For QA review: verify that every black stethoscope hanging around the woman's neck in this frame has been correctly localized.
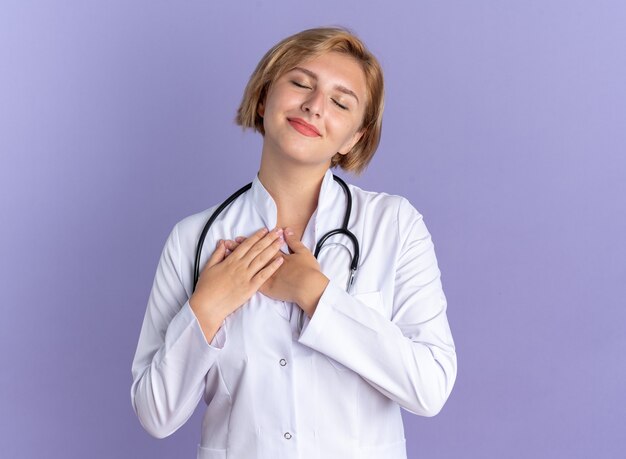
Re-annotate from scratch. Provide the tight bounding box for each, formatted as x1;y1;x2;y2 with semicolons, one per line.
192;174;359;330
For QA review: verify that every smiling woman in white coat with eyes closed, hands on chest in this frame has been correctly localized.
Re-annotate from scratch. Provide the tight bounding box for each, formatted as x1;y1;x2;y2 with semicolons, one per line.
131;28;456;459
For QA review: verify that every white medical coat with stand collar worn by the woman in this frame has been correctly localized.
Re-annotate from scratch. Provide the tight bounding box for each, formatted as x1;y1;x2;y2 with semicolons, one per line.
131;170;456;459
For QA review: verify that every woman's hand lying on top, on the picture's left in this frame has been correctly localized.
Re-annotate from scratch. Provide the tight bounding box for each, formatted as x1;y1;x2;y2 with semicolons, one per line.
189;228;284;342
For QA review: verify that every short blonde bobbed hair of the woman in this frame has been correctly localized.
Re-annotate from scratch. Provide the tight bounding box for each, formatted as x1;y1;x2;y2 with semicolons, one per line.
235;27;384;174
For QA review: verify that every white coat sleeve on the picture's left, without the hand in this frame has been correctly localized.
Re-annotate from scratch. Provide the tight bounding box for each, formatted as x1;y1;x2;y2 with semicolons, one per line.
131;227;223;438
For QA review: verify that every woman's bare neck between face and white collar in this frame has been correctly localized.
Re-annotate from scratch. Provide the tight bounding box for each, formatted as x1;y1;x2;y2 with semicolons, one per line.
259;151;328;232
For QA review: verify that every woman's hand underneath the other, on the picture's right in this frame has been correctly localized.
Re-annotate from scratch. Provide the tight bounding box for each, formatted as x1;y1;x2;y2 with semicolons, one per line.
227;228;329;317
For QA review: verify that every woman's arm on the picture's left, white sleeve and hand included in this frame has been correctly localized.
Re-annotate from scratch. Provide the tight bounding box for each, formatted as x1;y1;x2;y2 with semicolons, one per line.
131;225;282;438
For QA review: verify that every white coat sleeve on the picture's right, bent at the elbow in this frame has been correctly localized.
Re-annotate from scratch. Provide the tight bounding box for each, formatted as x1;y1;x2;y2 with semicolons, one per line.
300;199;456;416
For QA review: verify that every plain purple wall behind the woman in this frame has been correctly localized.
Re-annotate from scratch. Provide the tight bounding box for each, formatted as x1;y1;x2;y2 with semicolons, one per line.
0;0;626;458
